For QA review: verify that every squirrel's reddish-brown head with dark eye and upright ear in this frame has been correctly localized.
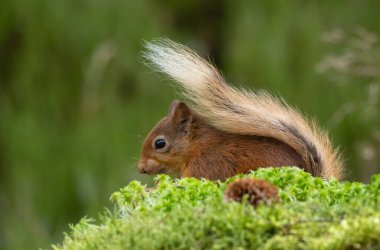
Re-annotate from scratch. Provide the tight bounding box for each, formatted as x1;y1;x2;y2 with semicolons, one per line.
138;101;194;174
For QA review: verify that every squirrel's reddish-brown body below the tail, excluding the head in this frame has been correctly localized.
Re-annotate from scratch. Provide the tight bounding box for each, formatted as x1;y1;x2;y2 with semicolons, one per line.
181;117;304;180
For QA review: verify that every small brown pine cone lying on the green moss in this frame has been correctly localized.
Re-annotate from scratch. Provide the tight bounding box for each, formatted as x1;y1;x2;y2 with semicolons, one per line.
224;178;280;207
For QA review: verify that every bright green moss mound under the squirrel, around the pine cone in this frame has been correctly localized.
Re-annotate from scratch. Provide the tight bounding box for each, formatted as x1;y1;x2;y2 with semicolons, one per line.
54;168;380;249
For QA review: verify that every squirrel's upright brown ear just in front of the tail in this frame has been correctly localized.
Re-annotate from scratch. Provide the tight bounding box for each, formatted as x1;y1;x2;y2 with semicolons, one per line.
168;100;192;134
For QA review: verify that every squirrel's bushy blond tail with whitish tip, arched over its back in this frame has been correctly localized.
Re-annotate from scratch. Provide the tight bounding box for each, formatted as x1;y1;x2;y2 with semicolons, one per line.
144;39;343;179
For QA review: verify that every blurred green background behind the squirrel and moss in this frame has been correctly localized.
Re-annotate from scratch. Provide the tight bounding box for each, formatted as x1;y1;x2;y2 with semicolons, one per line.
0;0;380;249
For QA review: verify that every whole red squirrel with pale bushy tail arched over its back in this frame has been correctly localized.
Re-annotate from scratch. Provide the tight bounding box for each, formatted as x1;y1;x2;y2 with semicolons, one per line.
138;39;343;180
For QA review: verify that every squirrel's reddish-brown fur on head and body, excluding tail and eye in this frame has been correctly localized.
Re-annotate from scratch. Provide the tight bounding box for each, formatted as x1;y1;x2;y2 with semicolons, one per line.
139;101;305;180
